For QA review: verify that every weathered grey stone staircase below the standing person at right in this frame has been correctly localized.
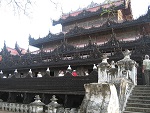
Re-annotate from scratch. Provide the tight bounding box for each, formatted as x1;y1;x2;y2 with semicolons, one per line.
123;85;150;113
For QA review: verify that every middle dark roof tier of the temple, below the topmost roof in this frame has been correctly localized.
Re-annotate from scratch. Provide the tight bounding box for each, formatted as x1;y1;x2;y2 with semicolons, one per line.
29;10;150;48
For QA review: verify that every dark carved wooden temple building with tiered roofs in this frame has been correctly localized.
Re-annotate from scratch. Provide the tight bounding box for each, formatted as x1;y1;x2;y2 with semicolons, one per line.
0;0;150;112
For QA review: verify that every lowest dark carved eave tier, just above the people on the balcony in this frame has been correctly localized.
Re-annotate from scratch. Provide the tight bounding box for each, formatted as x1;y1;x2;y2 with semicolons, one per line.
0;32;150;70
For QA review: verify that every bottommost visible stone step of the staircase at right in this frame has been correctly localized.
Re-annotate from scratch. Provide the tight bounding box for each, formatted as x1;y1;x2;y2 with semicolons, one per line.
125;107;150;113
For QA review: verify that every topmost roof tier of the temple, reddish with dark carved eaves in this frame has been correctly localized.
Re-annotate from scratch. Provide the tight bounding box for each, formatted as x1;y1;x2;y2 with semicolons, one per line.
53;0;130;25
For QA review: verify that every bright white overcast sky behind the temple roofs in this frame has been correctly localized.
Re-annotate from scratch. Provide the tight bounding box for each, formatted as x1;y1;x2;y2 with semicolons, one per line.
0;0;150;49
